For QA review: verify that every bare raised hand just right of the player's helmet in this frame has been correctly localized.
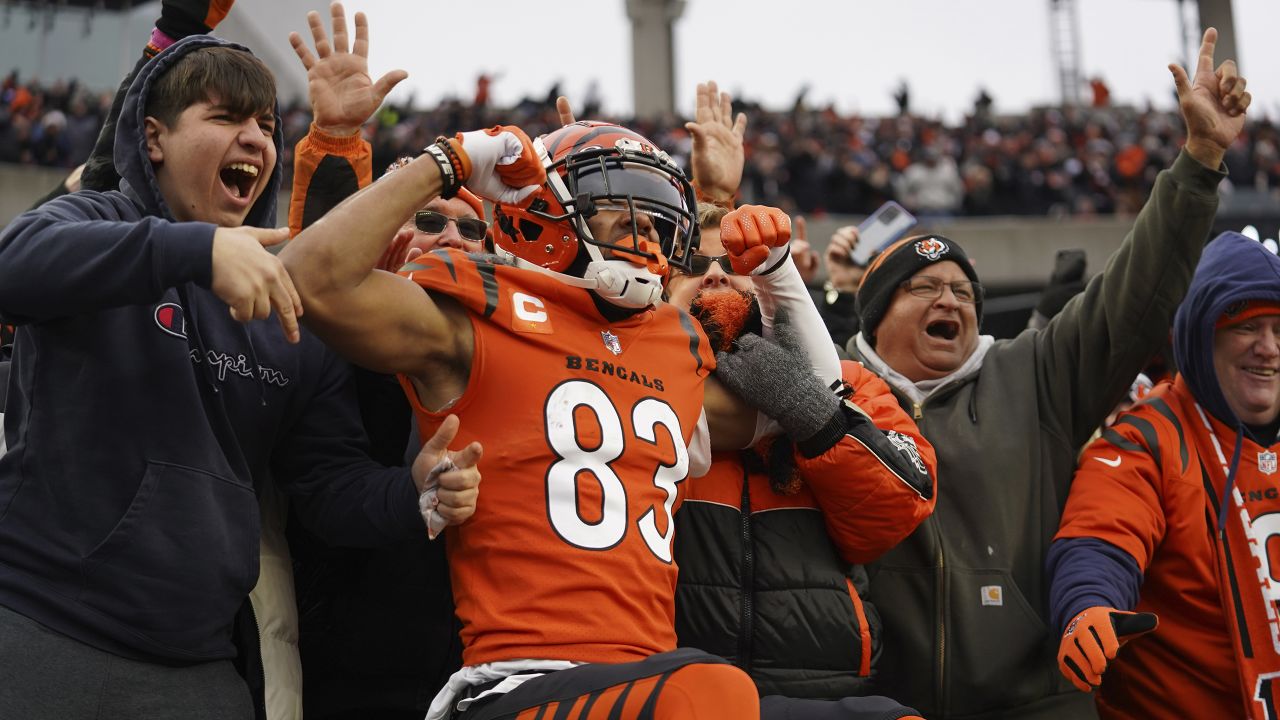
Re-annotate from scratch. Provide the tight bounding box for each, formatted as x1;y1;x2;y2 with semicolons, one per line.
685;81;746;205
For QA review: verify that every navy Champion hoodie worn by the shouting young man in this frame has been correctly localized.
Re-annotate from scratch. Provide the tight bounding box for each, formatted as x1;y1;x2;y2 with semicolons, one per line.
0;36;422;665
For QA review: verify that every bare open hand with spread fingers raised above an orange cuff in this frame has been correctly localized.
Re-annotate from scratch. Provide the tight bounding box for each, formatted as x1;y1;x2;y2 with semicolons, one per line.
289;3;408;137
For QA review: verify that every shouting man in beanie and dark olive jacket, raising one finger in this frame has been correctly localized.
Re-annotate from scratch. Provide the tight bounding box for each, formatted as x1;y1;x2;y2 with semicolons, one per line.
847;29;1249;720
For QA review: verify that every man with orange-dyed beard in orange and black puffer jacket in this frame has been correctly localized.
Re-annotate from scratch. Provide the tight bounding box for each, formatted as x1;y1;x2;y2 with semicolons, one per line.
667;205;934;720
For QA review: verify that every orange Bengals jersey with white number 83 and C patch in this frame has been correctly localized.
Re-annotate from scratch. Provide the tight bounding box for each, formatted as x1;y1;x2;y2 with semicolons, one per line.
401;250;716;665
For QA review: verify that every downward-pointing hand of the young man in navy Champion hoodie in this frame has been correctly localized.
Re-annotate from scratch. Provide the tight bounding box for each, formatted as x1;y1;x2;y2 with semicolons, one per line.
210;227;302;342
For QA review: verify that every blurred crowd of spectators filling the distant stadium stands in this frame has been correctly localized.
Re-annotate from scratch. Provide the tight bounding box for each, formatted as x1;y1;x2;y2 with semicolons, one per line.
0;73;1280;217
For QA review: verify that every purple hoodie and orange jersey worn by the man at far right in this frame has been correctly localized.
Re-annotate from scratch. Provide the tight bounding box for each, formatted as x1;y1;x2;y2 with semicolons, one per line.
1047;233;1280;717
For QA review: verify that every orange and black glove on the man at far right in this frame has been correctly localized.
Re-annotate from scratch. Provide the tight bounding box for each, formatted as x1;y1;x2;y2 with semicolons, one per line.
1057;606;1158;693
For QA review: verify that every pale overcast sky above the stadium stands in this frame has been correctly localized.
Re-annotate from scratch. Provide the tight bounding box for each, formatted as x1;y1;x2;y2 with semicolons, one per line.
335;0;1280;118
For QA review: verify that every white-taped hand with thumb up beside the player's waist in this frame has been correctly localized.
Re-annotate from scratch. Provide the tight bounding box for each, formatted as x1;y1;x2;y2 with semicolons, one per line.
411;415;483;538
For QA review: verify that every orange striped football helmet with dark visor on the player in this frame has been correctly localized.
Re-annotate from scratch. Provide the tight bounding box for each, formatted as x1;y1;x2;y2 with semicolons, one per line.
493;122;699;307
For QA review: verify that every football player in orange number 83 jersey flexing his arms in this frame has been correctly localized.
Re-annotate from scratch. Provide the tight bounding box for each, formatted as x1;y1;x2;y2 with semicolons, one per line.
282;10;788;717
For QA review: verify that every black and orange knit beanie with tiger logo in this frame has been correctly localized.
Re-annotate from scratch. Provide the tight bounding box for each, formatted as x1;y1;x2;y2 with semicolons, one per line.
858;234;982;347
